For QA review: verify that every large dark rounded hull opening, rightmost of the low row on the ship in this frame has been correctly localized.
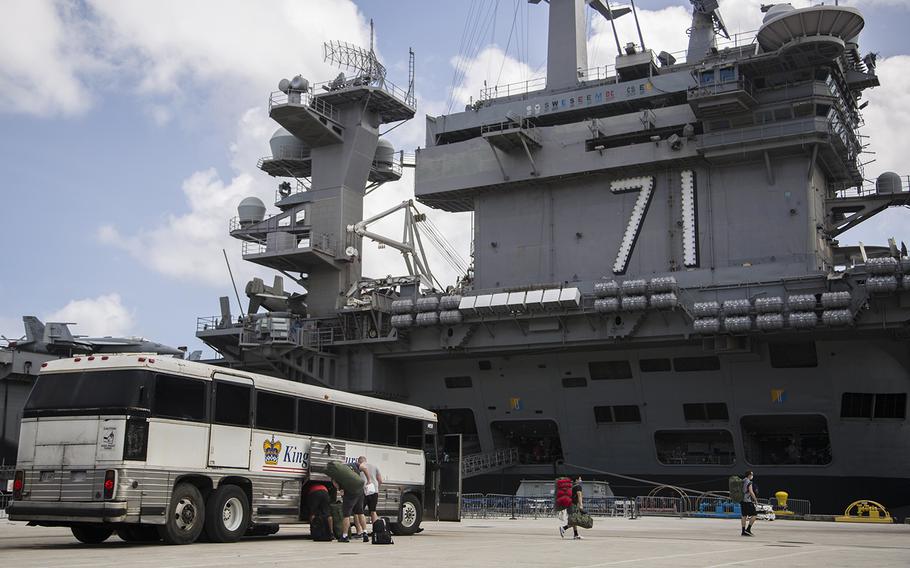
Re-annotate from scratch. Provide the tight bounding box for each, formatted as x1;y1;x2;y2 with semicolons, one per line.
740;414;831;465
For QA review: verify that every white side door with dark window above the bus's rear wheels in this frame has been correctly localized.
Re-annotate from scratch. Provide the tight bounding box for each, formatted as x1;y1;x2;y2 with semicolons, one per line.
208;373;253;469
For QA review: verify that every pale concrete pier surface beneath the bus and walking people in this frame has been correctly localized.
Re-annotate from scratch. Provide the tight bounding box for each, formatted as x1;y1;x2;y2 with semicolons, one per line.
0;517;910;568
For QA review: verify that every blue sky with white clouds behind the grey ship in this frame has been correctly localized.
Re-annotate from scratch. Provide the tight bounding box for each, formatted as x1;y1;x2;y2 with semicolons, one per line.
0;0;910;356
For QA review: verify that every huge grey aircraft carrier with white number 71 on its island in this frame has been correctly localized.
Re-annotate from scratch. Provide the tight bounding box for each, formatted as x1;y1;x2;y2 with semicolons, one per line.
197;0;910;513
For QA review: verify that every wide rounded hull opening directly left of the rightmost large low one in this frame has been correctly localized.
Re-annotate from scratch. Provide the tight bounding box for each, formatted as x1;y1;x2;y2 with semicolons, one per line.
654;430;736;465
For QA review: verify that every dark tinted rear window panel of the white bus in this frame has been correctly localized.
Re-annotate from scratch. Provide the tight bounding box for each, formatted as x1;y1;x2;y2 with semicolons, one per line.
24;370;153;416
